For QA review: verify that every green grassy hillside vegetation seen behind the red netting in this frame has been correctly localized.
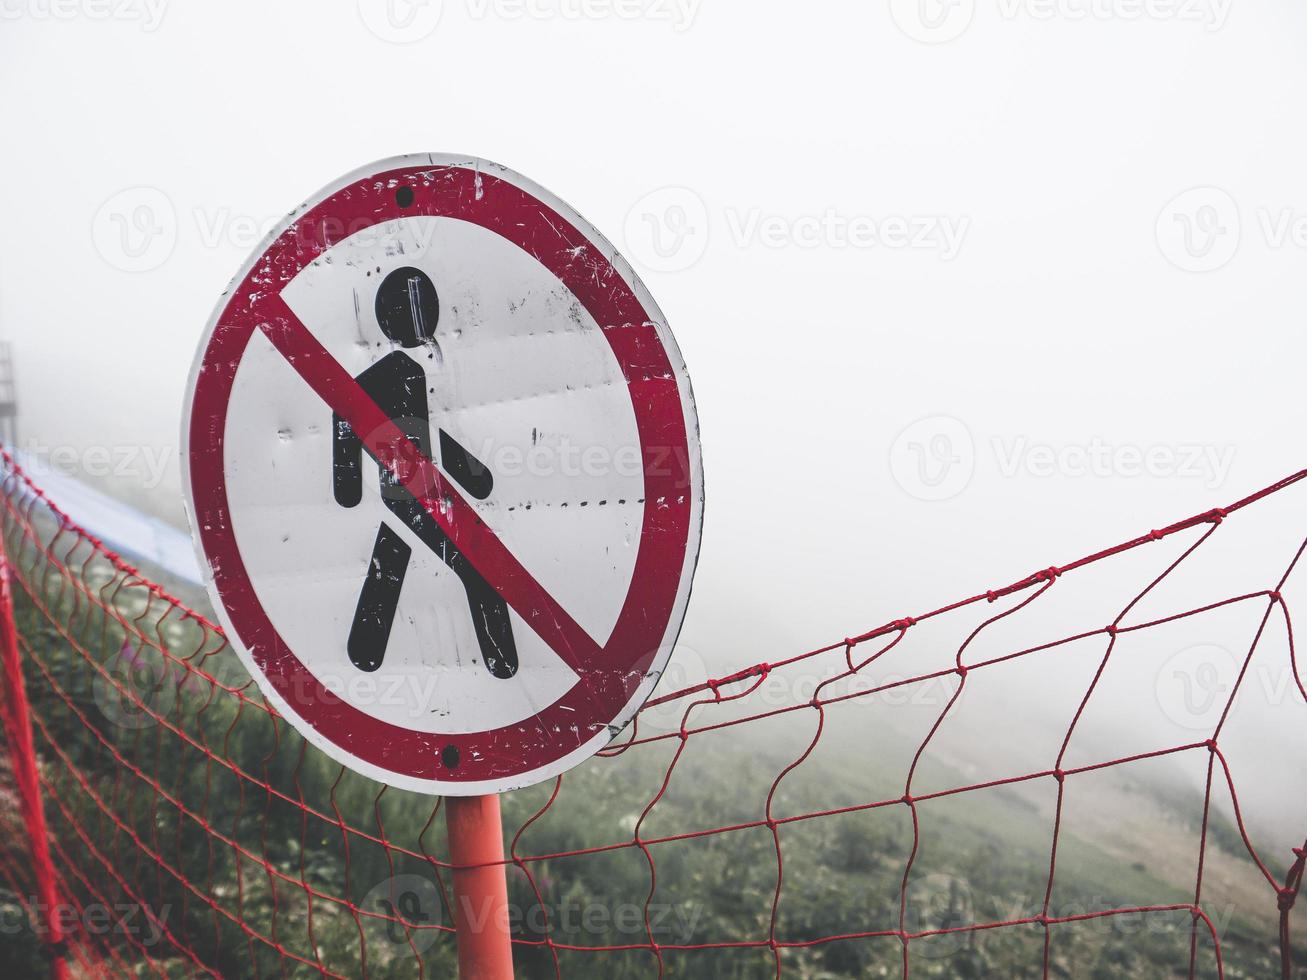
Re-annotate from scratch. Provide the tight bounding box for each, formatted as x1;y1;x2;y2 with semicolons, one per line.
0;509;1280;980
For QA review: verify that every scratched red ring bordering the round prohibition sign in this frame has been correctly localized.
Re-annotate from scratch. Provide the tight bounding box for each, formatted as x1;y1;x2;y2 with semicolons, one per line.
187;165;699;783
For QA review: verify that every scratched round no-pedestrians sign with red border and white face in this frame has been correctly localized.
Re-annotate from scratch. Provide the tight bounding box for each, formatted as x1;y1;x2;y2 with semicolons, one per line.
182;154;703;796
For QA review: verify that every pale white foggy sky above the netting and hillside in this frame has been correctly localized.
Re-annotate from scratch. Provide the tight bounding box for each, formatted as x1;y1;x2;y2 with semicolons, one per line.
0;0;1307;846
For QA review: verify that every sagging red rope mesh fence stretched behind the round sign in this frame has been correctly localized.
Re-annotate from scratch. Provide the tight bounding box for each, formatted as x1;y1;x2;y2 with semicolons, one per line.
0;457;1307;977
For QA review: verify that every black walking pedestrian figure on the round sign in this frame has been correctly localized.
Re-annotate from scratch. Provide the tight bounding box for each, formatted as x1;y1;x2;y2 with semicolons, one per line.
332;268;518;678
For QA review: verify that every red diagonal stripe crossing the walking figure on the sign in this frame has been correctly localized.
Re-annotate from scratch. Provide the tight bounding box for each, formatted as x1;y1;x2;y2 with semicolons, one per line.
260;295;603;677
